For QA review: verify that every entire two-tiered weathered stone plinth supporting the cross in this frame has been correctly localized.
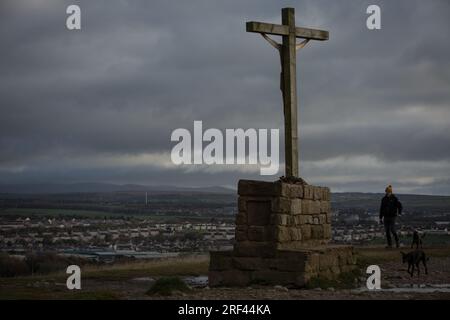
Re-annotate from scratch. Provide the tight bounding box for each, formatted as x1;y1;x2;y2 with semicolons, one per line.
209;180;355;287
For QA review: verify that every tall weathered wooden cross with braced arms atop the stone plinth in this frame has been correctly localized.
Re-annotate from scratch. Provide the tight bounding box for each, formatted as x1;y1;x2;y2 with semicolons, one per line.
247;8;328;178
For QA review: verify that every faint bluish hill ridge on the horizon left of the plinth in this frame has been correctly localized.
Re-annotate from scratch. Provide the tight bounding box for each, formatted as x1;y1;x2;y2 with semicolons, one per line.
0;183;236;194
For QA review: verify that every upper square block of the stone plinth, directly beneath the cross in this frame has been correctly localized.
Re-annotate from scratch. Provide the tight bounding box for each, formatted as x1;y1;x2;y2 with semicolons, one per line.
235;180;332;250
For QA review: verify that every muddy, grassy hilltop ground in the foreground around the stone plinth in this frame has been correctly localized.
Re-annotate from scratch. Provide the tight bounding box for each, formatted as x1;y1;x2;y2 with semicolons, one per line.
0;246;450;299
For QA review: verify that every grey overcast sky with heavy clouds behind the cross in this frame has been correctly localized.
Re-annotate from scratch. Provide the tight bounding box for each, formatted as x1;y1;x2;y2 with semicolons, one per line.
0;0;450;195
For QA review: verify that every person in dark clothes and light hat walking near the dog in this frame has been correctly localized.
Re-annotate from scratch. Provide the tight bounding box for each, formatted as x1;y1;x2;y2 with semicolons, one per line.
380;185;403;249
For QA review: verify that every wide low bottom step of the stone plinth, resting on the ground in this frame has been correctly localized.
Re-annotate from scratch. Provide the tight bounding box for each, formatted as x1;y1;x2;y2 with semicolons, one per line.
209;245;356;287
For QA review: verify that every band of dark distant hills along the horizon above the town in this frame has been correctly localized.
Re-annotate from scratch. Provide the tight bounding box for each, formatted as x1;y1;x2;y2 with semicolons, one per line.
0;183;450;216
